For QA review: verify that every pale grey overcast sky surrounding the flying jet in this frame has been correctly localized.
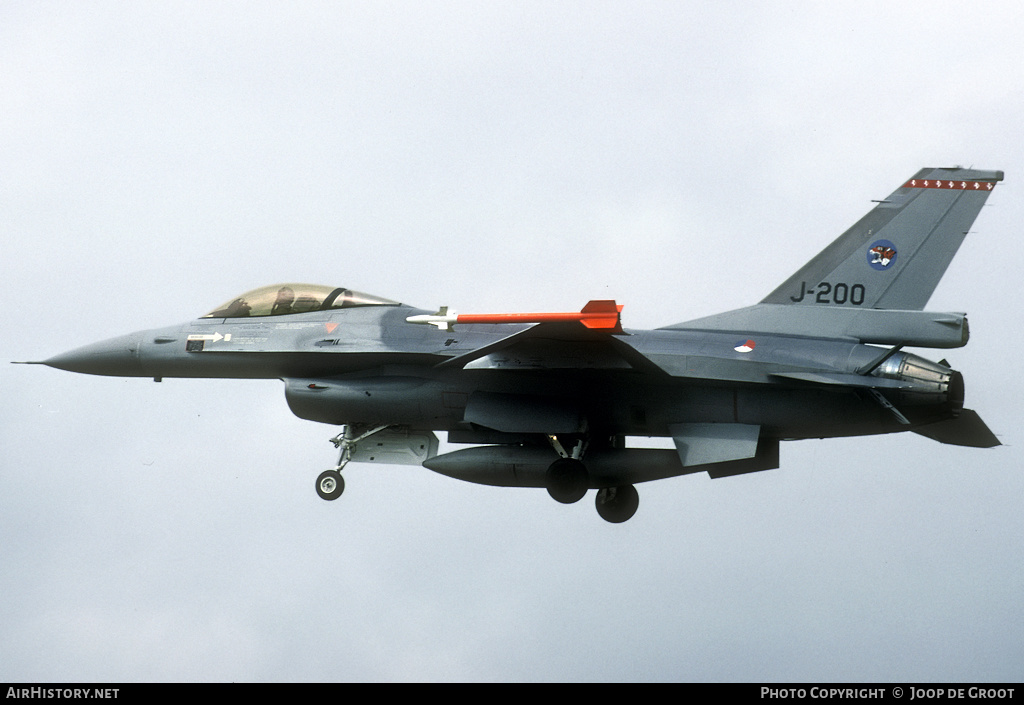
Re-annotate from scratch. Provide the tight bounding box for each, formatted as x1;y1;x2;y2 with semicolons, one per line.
0;0;1024;681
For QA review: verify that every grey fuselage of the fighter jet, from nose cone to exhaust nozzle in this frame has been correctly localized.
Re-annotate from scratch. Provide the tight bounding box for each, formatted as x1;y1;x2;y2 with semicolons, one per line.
46;306;963;443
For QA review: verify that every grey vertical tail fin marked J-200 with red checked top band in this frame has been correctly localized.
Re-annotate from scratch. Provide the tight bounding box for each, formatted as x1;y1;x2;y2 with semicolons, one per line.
761;168;1002;310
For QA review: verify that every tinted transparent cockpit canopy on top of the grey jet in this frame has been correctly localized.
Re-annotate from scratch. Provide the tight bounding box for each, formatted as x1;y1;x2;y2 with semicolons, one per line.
202;284;400;319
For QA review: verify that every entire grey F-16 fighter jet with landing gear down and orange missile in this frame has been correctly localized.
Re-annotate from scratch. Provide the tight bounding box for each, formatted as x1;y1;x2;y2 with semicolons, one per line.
29;168;1002;523
